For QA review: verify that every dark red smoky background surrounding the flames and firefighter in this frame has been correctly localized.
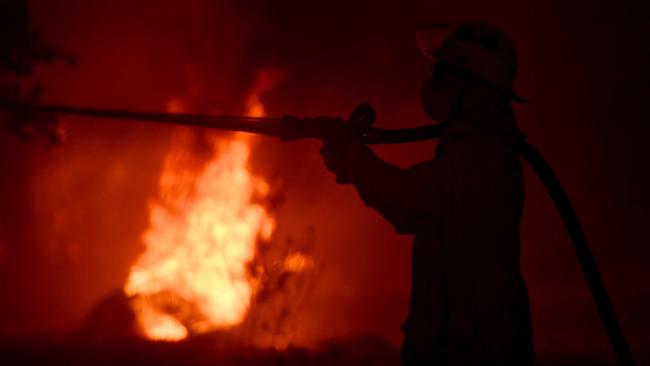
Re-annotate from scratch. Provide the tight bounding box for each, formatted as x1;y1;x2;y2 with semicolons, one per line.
0;0;650;364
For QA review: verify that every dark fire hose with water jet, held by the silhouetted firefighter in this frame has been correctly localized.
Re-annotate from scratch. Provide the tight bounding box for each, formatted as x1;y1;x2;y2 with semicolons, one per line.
0;103;634;366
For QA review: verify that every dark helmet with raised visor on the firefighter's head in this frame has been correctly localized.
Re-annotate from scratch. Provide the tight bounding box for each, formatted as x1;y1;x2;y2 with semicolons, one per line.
416;21;526;102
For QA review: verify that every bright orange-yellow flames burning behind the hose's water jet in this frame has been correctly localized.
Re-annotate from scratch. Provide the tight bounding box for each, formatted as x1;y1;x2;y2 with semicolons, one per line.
124;80;275;341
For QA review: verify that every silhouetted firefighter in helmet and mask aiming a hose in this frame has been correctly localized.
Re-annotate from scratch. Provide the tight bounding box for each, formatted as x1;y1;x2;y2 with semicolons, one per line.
321;22;533;366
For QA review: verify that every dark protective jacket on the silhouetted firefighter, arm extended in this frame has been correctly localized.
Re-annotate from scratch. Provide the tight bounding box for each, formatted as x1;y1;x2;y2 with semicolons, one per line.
334;116;533;366
